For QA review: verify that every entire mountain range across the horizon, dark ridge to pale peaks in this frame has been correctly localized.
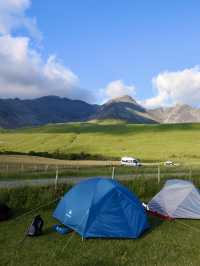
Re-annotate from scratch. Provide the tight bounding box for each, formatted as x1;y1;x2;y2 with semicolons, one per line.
0;95;200;128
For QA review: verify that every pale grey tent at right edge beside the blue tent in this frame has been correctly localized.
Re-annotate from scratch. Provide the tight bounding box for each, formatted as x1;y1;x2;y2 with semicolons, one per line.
148;179;200;219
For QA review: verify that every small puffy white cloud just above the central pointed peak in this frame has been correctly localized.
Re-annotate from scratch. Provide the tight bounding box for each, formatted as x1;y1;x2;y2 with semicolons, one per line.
104;80;136;99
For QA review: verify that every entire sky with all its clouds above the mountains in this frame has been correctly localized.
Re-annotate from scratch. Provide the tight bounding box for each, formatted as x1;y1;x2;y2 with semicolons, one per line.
0;0;200;108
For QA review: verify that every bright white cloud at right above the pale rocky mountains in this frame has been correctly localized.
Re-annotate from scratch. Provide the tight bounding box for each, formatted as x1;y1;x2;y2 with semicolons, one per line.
143;66;200;108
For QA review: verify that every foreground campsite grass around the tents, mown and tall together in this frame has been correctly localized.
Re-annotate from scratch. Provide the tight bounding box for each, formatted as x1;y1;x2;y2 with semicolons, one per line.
0;178;200;266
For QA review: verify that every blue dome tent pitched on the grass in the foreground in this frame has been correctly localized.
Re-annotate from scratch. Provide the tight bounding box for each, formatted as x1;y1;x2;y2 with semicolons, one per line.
53;178;149;238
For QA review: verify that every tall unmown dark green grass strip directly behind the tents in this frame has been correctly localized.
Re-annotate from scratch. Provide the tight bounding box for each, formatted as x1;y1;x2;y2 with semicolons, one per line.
0;177;200;210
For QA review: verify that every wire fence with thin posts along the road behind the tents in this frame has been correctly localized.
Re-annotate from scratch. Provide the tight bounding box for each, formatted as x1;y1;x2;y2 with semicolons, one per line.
0;161;200;183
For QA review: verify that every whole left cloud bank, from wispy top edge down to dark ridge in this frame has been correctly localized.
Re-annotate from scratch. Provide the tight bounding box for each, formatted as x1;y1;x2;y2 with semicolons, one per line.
0;0;94;101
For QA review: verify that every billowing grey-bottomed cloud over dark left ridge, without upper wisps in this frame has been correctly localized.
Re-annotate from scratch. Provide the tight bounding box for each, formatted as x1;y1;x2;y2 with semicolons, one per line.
0;35;88;98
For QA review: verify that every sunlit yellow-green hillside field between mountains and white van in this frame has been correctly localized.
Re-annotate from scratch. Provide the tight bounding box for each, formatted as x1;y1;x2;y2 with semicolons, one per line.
0;123;200;162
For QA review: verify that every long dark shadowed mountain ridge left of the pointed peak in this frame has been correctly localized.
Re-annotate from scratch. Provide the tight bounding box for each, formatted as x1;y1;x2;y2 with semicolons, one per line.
0;96;98;128
